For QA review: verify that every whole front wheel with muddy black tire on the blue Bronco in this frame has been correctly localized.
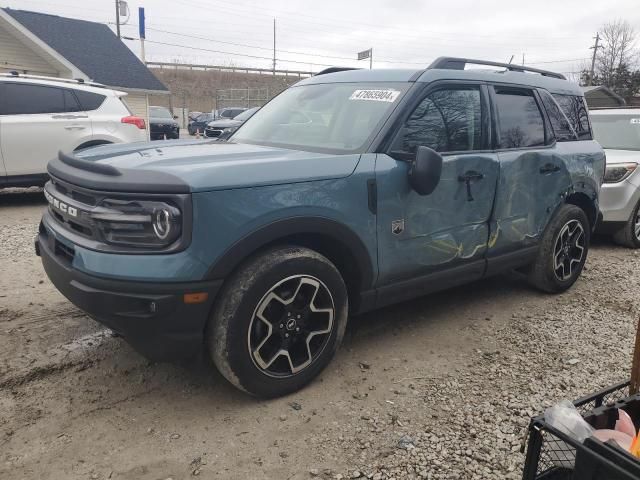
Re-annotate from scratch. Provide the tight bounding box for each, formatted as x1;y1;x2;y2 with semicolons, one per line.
205;246;348;398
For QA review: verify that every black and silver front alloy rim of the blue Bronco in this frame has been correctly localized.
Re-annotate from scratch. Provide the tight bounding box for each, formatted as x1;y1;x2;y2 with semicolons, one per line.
248;275;335;378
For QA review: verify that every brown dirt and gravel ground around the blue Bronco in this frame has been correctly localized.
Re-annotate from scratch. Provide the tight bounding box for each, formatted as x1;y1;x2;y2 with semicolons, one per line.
0;191;640;480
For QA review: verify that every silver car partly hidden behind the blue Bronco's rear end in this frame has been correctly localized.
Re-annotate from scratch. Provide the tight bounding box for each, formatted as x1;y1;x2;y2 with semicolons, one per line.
591;108;640;248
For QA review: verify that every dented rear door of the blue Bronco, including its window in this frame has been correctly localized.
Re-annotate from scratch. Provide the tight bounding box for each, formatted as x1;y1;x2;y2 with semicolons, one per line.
489;85;571;258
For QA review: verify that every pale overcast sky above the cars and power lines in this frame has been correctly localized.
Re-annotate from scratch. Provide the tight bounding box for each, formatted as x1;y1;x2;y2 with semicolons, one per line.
0;0;640;77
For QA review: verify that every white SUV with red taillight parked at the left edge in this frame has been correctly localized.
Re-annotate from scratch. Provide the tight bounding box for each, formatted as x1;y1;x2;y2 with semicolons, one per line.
0;73;147;188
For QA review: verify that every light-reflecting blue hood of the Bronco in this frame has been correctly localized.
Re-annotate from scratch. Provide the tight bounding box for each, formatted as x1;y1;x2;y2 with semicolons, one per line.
76;140;360;192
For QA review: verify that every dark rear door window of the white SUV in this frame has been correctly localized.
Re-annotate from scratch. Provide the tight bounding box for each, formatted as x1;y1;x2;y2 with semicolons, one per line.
0;83;68;115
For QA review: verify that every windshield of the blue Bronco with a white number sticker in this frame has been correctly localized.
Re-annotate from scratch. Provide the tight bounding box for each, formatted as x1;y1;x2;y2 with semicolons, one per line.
233;83;409;153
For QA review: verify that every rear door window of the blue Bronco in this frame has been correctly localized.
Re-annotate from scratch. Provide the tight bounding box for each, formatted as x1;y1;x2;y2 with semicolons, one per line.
495;87;545;148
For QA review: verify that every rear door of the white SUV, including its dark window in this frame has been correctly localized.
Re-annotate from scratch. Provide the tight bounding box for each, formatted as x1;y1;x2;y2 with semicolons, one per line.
0;83;91;176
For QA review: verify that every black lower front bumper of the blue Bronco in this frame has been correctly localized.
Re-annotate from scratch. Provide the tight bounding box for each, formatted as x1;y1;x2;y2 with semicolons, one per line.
35;230;222;360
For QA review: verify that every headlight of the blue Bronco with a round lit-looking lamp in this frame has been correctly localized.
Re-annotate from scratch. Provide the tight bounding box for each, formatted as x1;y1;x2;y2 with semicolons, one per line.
91;199;182;249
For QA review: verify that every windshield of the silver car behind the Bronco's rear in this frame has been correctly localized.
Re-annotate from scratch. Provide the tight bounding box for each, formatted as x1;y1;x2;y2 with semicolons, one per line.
591;110;640;150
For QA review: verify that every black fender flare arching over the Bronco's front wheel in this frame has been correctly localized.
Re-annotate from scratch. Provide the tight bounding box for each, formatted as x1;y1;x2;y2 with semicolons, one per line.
205;217;374;290
